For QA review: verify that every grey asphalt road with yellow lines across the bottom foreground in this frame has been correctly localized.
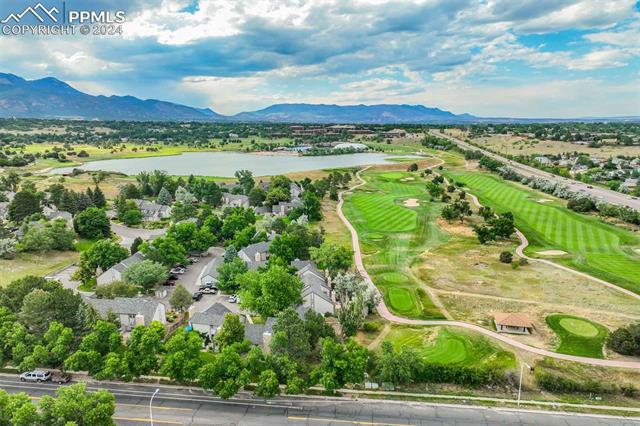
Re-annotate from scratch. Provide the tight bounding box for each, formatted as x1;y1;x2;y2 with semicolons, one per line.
0;376;640;426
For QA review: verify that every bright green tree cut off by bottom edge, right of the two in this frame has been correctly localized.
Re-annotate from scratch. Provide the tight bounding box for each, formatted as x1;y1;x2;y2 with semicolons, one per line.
40;383;116;426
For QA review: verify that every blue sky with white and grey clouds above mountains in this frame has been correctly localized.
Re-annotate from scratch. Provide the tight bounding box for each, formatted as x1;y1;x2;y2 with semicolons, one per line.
0;0;640;117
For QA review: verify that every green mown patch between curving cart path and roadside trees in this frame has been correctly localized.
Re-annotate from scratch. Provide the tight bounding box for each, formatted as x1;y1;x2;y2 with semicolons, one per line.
385;326;515;368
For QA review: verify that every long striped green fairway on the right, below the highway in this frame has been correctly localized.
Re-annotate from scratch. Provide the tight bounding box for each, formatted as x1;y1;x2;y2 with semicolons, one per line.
451;173;640;293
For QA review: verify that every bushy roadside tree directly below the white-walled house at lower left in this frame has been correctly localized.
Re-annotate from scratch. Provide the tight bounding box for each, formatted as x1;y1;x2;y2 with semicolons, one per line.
123;321;164;377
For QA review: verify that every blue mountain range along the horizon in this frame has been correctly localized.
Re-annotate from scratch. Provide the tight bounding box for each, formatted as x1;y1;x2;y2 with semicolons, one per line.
0;73;640;124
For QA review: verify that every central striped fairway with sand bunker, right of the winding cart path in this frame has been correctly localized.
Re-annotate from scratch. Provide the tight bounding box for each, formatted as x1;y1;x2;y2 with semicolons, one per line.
344;171;447;318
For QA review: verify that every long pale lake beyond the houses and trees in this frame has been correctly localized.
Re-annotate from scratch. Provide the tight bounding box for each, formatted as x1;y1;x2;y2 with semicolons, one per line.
52;152;416;177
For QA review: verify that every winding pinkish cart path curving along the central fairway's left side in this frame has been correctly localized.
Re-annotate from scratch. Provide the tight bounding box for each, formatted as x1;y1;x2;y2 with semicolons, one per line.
336;164;640;369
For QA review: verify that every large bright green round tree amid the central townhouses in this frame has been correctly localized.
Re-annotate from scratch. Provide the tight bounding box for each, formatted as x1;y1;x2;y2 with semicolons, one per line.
236;265;302;318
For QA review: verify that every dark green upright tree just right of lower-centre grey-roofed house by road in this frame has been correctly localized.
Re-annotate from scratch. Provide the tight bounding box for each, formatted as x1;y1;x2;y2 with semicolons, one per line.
270;307;311;361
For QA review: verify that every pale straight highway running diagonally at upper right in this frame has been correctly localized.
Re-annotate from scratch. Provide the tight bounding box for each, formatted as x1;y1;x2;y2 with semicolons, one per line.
431;130;640;210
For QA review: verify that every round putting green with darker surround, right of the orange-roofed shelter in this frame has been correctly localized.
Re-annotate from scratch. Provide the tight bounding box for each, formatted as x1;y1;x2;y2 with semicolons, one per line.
546;314;609;358
